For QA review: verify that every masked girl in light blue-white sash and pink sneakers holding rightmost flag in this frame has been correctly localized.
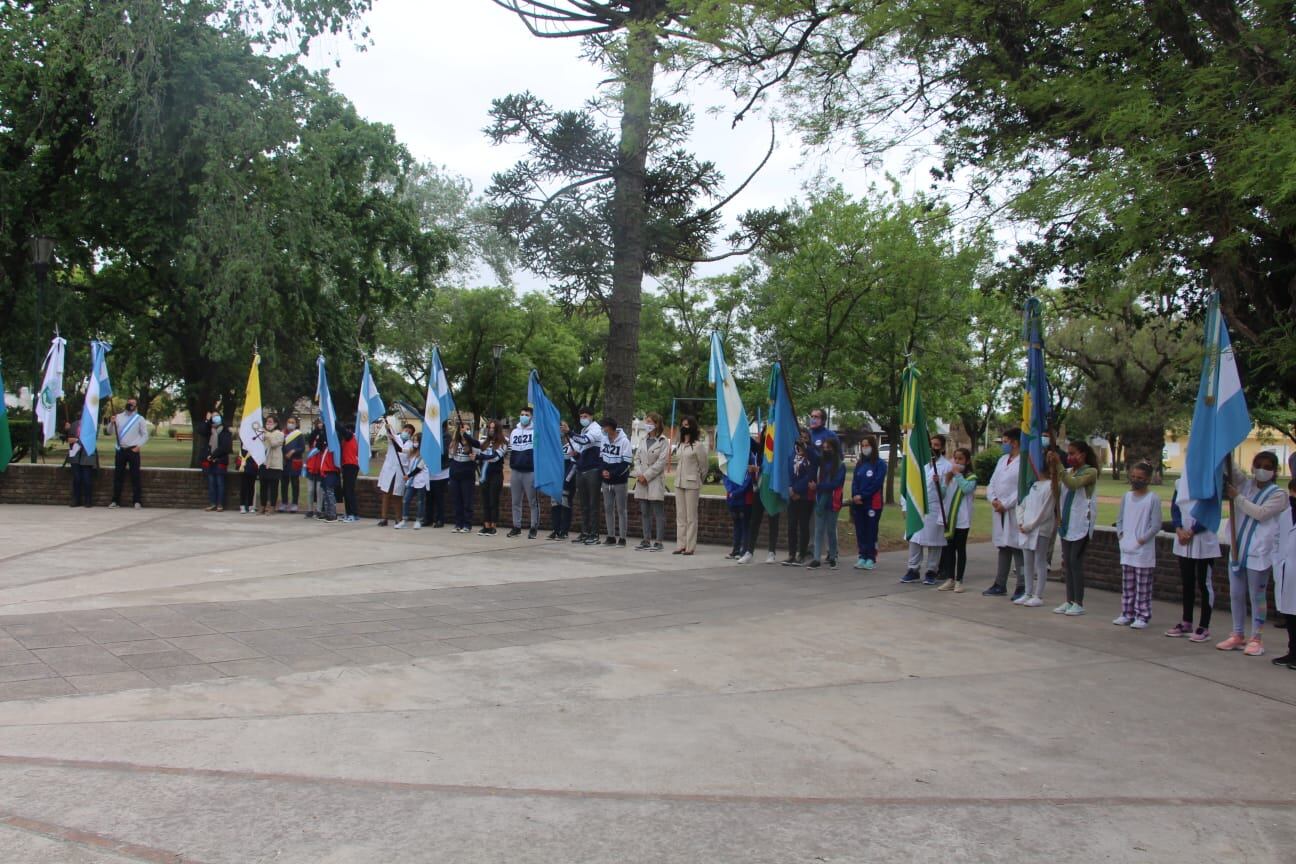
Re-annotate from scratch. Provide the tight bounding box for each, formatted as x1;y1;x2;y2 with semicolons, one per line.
1216;451;1287;657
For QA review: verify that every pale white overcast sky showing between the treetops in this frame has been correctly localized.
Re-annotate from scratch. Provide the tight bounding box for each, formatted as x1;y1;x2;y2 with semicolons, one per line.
300;0;924;289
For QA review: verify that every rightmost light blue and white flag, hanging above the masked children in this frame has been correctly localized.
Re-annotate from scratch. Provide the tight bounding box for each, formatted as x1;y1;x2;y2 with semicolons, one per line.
1183;293;1251;531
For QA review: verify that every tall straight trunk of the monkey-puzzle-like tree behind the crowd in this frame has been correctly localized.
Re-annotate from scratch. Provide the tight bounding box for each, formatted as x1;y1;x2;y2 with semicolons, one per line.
603;13;658;422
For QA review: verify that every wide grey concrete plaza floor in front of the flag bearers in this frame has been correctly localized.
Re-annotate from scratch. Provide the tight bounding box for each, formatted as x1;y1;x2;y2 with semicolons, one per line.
0;506;1296;864
